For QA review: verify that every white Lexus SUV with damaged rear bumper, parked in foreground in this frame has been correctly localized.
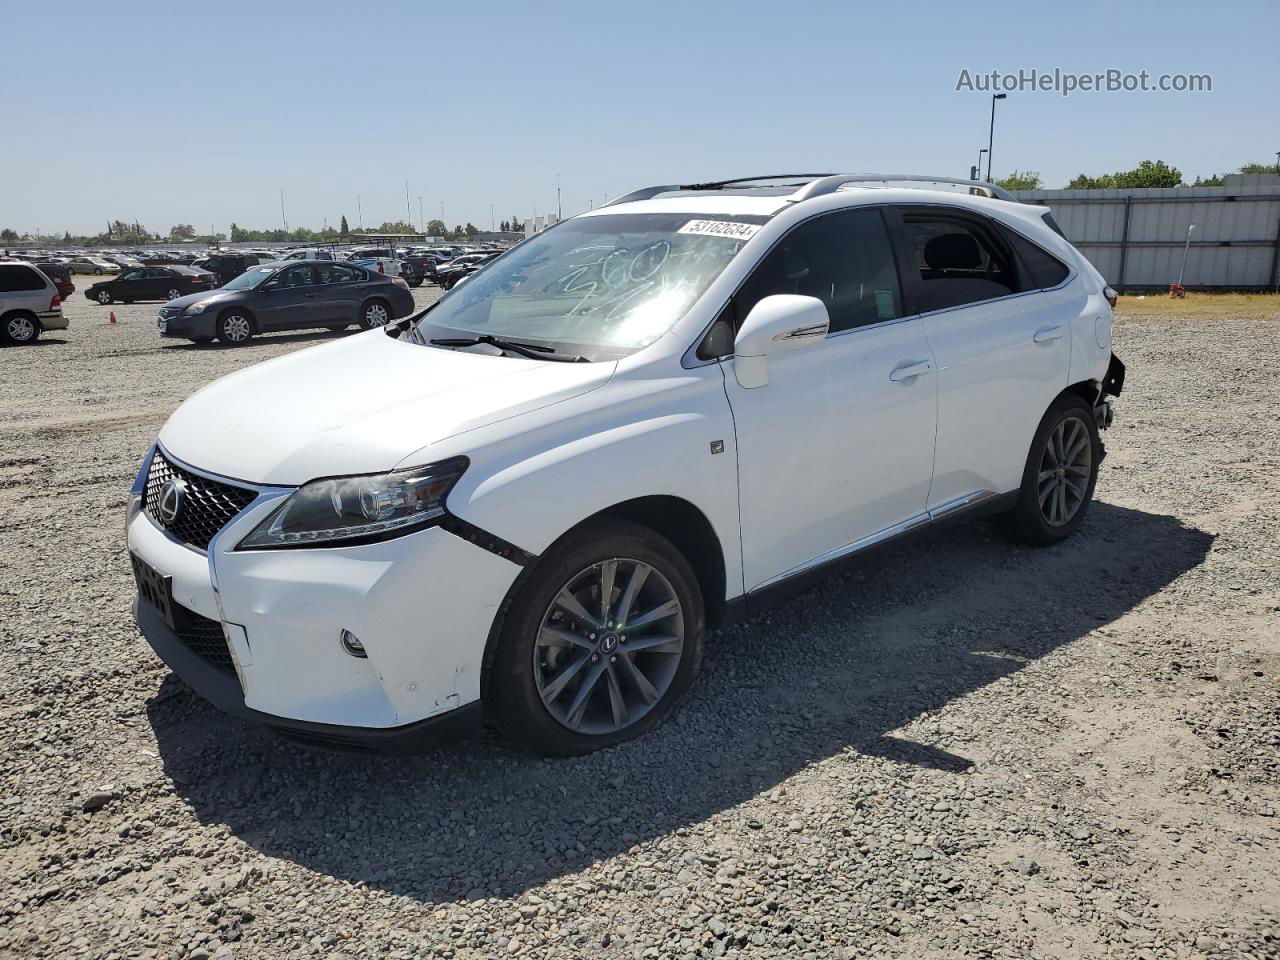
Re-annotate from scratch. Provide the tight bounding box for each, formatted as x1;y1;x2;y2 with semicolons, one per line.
128;175;1124;754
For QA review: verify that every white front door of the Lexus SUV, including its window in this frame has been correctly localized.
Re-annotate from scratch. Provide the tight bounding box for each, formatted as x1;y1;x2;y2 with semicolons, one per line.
724;207;938;591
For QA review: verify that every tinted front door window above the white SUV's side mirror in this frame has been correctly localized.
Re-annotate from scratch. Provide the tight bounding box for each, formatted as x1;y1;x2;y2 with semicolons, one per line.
735;210;902;332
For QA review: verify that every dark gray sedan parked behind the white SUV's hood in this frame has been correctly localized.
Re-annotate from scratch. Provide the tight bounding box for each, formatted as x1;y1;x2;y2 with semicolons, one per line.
159;260;413;347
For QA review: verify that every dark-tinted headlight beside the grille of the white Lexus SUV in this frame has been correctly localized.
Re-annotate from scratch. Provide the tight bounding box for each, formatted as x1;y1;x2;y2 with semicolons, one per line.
238;457;467;549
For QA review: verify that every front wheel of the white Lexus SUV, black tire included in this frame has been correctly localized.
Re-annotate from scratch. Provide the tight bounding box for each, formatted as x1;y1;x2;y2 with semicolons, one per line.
486;521;705;756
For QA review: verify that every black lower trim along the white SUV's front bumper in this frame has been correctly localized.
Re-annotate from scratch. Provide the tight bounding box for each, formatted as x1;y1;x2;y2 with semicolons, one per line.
133;598;483;755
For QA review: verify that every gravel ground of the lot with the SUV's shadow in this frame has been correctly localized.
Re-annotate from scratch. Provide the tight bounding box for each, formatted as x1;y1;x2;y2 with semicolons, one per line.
0;288;1280;960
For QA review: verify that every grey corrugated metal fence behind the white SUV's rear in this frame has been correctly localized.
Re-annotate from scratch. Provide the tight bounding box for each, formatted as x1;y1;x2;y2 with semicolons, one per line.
1015;174;1280;292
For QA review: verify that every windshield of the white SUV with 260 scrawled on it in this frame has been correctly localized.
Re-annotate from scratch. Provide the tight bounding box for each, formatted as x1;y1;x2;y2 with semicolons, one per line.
420;214;765;360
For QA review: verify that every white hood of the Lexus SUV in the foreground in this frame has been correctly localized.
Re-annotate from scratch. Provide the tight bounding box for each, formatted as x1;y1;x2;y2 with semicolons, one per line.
160;330;617;486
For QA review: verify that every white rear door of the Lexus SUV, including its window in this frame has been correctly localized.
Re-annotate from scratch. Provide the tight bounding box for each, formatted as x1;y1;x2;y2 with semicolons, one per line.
892;205;1071;511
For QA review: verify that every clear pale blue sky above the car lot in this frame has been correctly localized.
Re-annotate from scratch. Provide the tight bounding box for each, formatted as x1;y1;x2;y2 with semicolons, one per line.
0;0;1280;233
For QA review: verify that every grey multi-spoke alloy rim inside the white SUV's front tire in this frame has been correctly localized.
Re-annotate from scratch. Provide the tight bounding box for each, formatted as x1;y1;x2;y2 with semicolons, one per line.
534;558;685;736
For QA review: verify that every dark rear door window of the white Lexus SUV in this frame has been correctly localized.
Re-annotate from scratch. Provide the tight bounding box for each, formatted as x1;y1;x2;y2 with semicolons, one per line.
902;212;1020;312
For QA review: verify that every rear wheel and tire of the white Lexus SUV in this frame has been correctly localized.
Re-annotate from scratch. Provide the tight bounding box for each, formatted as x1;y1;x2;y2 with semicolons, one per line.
1002;394;1102;547
